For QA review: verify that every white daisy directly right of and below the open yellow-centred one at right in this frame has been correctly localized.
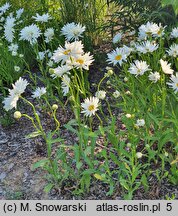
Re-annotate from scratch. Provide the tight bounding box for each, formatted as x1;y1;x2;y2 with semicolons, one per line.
128;60;150;76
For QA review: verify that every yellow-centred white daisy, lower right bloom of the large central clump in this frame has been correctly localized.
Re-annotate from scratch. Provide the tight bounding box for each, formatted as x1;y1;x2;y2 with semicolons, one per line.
72;52;94;70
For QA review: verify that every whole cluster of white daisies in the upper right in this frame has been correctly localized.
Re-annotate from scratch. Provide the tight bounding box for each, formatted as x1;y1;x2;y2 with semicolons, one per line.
107;22;178;93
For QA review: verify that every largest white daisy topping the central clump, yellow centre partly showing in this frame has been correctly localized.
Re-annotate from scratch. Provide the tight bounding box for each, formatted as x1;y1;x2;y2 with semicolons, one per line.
52;41;84;64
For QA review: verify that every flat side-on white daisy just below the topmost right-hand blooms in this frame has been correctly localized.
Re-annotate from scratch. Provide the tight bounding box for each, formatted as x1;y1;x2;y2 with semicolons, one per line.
136;41;158;54
